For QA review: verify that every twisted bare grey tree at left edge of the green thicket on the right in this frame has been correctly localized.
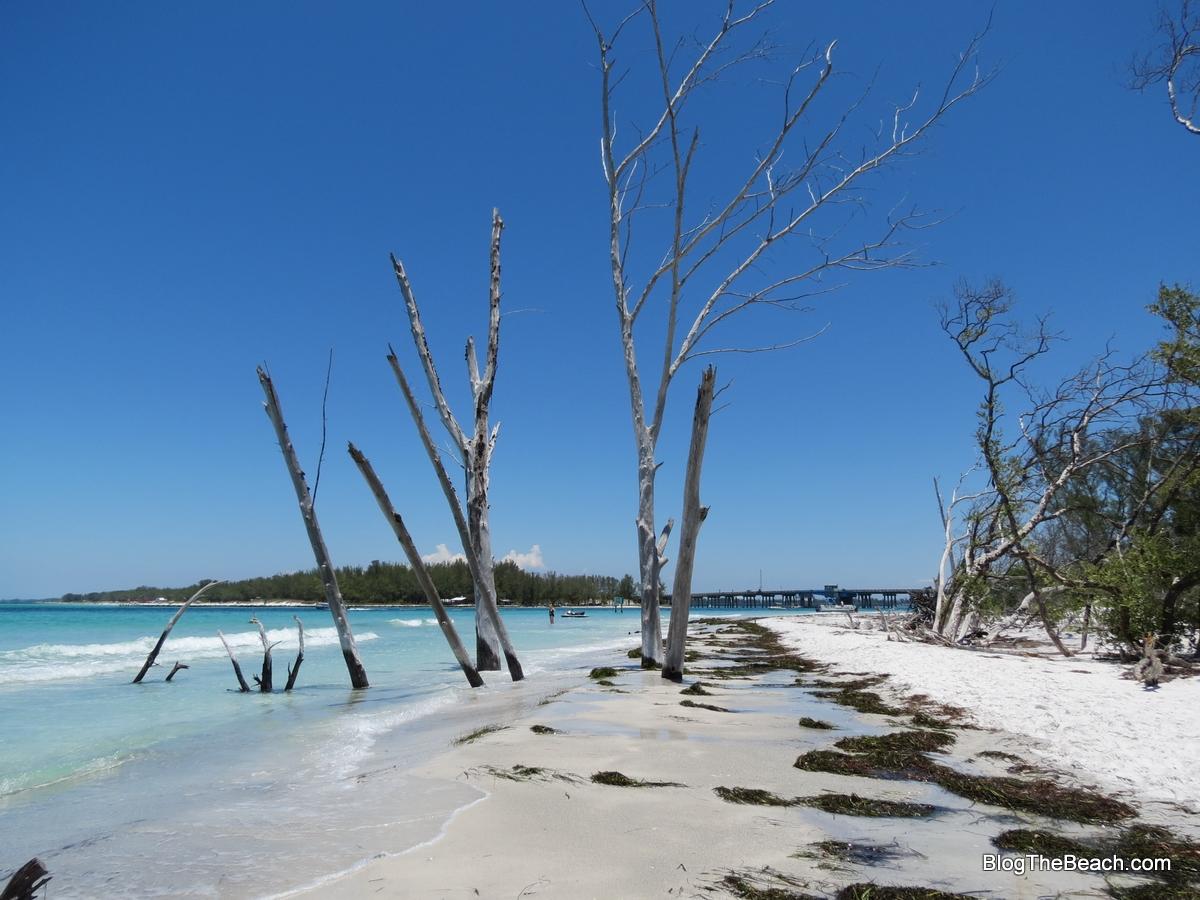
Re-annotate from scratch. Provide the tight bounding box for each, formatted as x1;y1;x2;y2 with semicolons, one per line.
934;280;1159;655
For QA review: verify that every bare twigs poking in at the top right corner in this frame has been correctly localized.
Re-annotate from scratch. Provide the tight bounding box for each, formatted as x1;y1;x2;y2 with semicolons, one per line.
1129;0;1200;134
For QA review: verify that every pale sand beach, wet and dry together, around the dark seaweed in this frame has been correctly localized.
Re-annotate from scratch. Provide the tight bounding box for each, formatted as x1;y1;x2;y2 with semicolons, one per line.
299;616;1196;900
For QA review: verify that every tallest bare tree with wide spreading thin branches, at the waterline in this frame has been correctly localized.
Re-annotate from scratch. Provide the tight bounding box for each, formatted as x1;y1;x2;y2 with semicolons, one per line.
584;0;991;667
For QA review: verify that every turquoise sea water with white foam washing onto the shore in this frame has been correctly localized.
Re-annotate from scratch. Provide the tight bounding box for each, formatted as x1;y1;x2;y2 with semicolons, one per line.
0;604;806;898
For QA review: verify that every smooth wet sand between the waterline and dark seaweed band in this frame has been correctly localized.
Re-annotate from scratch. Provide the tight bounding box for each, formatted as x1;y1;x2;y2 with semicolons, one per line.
288;629;1190;900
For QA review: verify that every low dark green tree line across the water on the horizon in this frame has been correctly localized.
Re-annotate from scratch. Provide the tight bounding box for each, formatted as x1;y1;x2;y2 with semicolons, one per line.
60;559;636;606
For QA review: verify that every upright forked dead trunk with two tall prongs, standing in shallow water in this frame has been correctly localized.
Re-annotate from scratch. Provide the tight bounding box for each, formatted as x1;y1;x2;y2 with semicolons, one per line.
391;209;504;672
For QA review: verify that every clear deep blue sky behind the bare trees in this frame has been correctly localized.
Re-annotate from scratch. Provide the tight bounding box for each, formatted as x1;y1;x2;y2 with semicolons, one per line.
0;0;1200;596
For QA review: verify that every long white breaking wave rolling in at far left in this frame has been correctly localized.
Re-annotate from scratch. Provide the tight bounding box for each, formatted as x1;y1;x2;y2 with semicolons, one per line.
0;628;379;684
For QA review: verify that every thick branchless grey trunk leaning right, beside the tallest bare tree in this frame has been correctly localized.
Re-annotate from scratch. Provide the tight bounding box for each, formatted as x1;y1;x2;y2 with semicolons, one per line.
662;366;716;682
